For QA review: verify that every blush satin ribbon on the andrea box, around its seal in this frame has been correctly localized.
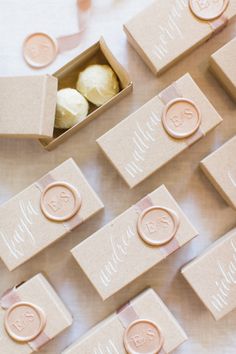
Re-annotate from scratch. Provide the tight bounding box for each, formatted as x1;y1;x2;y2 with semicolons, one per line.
135;195;180;257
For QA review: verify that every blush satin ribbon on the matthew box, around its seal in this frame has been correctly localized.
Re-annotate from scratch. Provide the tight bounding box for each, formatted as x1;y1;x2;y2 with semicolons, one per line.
158;82;205;147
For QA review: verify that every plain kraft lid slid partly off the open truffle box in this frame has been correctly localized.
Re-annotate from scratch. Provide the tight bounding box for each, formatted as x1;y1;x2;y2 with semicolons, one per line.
0;75;57;138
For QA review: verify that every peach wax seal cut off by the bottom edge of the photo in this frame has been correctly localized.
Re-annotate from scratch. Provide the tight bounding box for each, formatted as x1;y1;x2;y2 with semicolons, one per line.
124;319;164;354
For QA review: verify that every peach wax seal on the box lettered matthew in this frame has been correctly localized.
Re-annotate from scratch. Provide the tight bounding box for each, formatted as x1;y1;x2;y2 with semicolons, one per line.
162;98;201;139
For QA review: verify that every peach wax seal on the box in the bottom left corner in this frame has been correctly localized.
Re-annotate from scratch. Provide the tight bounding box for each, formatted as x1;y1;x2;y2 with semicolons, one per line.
4;302;46;342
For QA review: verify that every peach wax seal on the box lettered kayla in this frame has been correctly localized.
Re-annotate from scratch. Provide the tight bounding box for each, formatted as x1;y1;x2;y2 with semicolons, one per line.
40;182;81;221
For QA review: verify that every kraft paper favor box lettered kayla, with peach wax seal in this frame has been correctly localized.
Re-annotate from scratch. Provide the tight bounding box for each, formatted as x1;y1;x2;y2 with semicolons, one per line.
0;159;103;270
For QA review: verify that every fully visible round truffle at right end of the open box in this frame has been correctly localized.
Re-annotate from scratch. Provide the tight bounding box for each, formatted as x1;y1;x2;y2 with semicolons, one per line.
76;64;119;106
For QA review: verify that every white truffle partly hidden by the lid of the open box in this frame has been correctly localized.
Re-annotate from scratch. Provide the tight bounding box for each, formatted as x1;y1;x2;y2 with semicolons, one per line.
55;88;89;129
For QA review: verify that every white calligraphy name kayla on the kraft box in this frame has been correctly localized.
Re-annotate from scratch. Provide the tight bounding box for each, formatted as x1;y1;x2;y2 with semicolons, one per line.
0;200;39;259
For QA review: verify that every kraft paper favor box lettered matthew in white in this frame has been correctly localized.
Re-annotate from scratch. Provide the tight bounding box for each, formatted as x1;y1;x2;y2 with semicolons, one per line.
97;74;222;188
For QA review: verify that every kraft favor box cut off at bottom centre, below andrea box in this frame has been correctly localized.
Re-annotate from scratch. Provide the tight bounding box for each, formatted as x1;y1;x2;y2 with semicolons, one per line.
62;289;187;354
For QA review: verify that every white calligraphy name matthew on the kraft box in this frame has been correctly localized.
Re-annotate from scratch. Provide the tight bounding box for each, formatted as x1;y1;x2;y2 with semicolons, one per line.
125;112;161;178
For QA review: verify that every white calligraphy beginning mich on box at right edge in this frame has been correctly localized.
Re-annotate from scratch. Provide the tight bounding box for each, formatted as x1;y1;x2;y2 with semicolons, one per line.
211;239;236;312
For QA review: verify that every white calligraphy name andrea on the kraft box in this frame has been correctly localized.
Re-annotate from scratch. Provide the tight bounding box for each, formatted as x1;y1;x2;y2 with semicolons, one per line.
99;226;135;287
